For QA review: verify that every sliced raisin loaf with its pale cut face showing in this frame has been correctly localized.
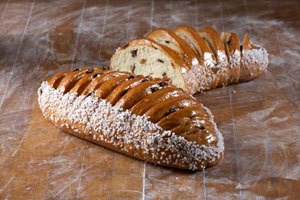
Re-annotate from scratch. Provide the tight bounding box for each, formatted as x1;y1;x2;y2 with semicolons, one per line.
110;26;268;94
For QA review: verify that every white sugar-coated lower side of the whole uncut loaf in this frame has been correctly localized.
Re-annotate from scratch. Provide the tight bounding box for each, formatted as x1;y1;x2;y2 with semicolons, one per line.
38;82;224;170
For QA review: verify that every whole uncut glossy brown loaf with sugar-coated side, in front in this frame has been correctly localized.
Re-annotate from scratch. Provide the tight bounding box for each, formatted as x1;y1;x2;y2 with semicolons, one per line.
38;67;224;170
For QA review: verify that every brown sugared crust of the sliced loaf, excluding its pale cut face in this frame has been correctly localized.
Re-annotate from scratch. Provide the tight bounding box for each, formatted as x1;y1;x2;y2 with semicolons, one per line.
110;26;268;94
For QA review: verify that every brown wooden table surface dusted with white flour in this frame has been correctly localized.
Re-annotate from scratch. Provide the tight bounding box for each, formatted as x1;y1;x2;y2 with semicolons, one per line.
0;0;300;200
